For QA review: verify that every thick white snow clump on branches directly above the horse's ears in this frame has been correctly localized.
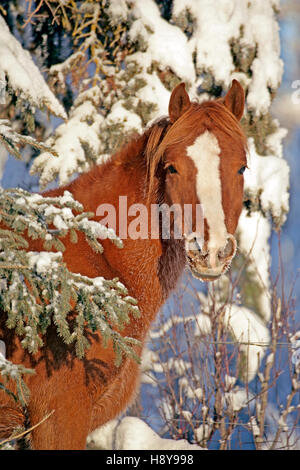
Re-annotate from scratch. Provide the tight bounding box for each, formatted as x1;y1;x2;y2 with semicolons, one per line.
173;0;283;114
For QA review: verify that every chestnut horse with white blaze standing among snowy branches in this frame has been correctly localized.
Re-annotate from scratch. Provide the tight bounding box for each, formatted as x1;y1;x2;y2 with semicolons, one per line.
0;80;247;449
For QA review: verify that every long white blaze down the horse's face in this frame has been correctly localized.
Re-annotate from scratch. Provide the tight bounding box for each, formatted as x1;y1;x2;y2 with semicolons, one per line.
187;131;228;267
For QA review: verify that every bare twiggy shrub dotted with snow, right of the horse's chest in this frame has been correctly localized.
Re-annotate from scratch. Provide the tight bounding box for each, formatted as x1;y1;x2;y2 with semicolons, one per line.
139;272;300;450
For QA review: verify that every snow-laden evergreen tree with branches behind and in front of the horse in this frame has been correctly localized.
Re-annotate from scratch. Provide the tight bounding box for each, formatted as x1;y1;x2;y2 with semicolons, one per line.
0;0;289;448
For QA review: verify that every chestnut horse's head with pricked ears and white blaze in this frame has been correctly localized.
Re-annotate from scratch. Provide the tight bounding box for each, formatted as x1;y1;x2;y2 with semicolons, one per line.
156;80;247;281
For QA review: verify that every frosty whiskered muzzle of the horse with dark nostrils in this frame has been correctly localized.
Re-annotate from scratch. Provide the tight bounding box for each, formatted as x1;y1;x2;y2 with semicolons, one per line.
185;233;237;281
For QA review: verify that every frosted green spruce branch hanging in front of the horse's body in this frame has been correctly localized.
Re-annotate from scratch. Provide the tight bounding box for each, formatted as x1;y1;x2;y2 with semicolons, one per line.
0;189;139;365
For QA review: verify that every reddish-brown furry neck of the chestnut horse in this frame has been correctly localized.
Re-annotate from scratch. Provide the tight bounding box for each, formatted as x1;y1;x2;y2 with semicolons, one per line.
46;129;185;323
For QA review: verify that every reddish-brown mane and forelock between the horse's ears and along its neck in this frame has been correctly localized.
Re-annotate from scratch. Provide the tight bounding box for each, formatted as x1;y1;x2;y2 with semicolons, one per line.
79;99;247;201
